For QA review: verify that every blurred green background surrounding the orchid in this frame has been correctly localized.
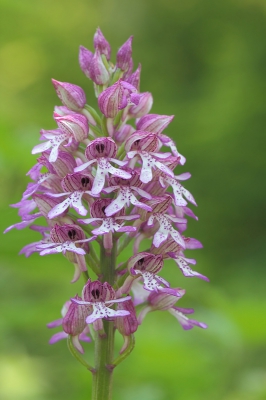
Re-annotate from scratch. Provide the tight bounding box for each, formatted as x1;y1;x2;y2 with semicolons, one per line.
0;0;266;400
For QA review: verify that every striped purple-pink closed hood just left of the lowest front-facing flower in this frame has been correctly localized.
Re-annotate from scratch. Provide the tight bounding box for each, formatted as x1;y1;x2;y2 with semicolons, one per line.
62;295;90;336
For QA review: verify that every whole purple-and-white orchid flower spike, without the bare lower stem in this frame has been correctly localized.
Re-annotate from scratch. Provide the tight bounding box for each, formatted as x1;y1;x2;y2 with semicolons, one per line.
6;29;208;352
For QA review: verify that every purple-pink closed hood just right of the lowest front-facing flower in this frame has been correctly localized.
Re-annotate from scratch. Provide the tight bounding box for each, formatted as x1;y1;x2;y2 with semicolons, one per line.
115;300;138;336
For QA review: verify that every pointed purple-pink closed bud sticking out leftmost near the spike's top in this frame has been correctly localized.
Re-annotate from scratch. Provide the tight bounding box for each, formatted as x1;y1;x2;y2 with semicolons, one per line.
52;79;86;111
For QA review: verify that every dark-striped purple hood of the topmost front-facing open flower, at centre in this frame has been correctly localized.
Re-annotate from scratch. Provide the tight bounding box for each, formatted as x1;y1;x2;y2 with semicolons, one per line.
85;137;117;160
